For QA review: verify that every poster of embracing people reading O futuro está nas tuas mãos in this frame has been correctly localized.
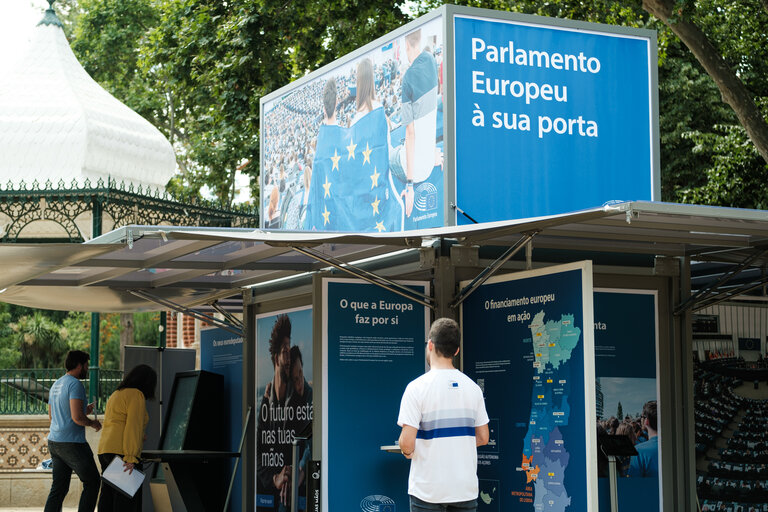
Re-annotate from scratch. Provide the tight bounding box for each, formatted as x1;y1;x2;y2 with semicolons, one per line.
256;307;314;512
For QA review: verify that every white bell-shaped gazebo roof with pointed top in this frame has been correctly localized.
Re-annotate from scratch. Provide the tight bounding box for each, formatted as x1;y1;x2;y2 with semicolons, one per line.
0;1;176;188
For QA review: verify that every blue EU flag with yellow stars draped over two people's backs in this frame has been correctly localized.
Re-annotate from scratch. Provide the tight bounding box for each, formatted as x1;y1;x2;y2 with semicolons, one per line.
304;107;403;232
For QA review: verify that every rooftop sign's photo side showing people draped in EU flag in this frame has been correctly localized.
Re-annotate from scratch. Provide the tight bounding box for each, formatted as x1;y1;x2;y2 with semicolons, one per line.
261;18;444;232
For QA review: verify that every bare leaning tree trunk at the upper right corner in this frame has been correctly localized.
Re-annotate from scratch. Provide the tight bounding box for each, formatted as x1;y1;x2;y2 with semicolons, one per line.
643;0;768;163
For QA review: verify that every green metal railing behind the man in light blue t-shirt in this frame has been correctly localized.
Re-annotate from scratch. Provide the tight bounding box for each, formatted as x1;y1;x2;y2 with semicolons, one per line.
0;368;123;415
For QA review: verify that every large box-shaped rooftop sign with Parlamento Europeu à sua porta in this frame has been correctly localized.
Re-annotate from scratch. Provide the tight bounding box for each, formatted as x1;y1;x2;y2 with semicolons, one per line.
260;5;660;232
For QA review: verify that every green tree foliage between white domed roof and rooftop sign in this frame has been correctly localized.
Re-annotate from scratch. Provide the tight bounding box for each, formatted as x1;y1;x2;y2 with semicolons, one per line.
68;0;407;205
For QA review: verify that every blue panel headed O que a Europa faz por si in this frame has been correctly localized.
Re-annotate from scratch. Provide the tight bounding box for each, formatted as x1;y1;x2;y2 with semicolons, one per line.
322;279;429;512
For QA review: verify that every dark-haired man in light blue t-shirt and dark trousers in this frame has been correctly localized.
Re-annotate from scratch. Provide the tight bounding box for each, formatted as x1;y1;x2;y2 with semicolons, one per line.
44;350;101;512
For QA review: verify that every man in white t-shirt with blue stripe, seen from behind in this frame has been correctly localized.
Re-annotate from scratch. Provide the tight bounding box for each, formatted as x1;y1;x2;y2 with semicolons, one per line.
397;318;488;512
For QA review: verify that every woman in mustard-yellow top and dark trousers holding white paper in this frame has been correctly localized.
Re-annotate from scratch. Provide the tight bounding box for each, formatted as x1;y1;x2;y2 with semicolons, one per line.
98;364;157;512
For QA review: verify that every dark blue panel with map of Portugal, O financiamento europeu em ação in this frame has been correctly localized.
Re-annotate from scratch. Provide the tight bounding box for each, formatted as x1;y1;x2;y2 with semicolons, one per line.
461;262;597;512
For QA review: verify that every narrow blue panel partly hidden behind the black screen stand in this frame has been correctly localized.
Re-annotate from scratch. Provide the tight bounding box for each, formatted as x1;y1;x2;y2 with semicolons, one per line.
200;328;243;512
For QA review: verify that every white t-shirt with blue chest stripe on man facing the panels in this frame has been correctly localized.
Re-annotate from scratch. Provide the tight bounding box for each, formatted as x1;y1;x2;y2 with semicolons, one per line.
397;369;488;503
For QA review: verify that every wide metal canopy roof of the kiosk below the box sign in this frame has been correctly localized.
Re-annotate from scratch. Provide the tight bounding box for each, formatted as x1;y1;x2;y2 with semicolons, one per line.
0;202;768;312
